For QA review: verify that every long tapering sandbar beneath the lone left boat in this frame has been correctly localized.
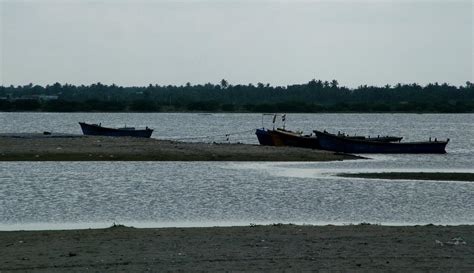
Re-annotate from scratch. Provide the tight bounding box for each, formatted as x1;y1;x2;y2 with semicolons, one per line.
0;134;361;161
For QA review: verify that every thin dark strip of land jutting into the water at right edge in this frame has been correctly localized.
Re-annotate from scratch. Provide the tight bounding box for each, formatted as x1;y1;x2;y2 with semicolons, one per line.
339;172;474;181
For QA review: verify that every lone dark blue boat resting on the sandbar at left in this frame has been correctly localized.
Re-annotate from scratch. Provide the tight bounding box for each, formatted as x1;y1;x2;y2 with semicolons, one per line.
79;122;153;138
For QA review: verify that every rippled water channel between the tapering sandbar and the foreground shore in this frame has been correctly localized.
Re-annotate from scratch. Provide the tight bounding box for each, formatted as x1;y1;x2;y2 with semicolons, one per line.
0;160;474;226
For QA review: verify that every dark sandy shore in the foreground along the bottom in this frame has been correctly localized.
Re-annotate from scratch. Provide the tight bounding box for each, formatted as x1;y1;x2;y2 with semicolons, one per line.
0;225;474;272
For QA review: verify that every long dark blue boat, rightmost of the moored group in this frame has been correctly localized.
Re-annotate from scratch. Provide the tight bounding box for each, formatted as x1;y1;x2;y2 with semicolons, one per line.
314;130;449;154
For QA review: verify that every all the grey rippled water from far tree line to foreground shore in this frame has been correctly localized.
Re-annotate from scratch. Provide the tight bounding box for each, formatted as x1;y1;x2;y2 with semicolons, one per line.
0;113;474;229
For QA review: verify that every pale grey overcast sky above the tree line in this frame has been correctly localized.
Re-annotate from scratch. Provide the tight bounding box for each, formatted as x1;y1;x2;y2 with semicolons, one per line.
0;0;474;87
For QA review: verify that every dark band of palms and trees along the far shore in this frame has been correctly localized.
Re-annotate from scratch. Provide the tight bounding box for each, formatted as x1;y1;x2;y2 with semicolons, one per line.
0;80;474;113
